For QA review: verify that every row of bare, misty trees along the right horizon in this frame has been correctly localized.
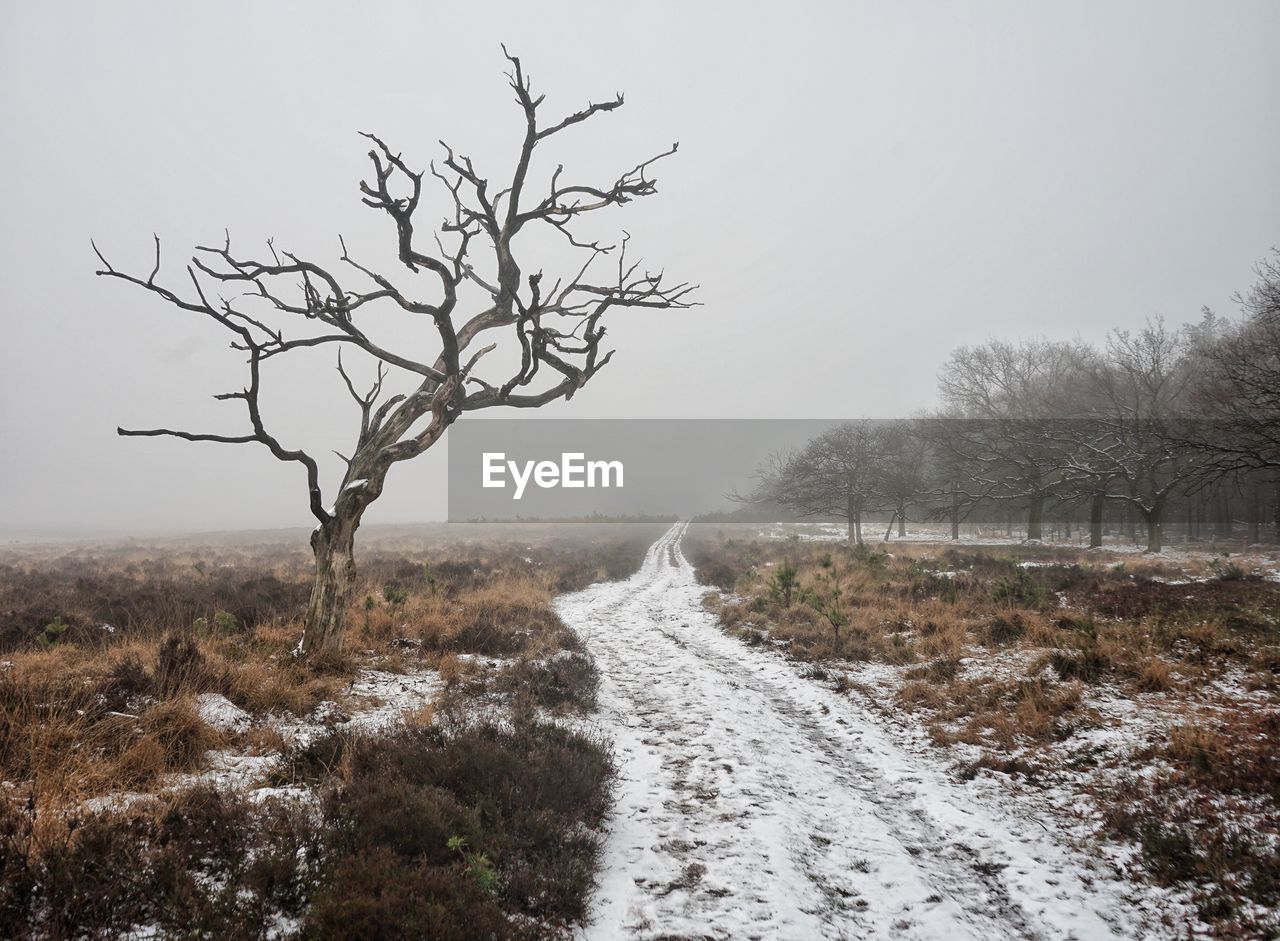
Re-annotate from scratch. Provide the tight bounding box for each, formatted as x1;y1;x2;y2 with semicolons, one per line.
742;252;1280;552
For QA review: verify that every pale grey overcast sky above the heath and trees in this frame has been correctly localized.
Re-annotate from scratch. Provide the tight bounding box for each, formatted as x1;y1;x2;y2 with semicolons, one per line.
0;0;1280;535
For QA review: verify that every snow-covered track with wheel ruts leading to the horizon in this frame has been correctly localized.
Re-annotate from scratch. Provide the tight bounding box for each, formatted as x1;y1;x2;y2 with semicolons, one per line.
557;524;1160;941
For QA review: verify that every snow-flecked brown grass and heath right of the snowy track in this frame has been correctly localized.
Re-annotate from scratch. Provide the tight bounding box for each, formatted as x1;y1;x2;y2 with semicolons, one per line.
686;526;1280;937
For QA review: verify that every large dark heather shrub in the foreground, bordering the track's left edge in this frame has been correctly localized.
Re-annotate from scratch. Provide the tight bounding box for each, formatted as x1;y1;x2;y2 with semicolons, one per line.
307;720;613;938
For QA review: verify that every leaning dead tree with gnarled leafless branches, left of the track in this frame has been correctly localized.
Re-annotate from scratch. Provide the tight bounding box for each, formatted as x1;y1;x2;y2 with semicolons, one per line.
93;47;694;654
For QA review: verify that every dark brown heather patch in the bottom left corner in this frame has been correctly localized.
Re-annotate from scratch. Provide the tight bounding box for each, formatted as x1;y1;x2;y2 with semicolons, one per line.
0;787;320;938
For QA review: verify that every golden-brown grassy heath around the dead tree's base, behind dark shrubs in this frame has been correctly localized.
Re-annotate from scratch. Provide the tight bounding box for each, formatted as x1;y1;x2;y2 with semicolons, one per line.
0;525;660;810
